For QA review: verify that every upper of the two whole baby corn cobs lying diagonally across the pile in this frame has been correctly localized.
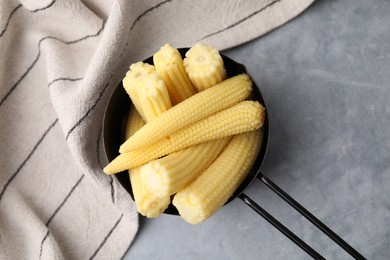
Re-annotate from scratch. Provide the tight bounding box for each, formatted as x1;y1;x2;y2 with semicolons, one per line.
119;74;252;153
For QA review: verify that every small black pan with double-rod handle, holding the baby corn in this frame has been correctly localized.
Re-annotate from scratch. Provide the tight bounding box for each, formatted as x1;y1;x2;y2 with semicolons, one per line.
103;48;365;259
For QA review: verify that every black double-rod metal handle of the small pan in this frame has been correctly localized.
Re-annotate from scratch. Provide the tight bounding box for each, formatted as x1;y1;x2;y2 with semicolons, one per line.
239;172;366;260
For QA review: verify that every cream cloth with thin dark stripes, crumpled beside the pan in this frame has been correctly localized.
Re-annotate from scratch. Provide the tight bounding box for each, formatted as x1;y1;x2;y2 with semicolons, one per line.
0;0;313;259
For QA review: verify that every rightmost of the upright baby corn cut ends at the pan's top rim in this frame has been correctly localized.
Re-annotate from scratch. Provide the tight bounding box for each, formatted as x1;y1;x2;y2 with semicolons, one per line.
183;43;227;91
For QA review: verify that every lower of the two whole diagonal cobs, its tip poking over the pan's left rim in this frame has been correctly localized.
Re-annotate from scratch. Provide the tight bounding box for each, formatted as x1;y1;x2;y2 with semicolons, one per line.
103;100;264;174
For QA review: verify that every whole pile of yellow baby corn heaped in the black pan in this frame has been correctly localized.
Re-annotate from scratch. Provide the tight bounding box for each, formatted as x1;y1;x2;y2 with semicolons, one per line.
104;43;264;224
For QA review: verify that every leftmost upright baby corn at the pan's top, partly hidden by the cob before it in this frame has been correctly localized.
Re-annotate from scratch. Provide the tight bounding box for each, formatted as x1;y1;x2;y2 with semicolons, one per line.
122;61;156;120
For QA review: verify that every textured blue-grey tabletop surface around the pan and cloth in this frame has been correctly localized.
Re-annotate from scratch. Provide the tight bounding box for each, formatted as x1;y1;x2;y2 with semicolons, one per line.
125;0;390;259
